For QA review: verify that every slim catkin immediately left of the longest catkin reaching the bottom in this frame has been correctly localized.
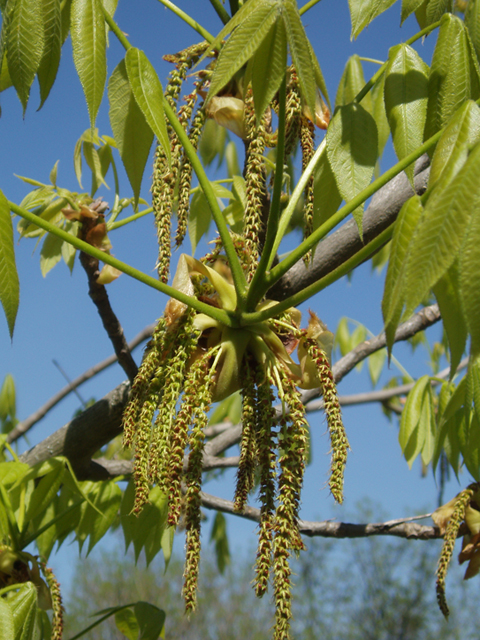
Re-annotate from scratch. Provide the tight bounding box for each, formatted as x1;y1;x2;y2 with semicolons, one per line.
255;373;276;597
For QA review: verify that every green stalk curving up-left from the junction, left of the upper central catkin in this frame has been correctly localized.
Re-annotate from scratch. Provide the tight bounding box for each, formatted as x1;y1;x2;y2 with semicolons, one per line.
163;100;246;311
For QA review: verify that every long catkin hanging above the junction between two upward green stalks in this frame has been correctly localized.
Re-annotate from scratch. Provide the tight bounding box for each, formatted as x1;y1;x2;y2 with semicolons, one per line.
244;88;267;280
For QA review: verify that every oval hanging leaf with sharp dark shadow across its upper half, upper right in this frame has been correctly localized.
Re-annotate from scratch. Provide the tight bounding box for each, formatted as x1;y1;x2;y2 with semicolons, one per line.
385;44;428;184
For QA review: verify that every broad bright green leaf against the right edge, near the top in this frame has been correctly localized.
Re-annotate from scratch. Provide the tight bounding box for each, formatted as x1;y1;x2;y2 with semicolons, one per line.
425;14;480;138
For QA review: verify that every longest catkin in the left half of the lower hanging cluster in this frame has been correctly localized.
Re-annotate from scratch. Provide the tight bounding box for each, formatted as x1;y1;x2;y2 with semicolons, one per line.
183;349;218;613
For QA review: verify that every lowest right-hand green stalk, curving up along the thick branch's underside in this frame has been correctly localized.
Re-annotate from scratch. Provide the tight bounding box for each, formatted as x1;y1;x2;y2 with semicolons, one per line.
242;222;395;325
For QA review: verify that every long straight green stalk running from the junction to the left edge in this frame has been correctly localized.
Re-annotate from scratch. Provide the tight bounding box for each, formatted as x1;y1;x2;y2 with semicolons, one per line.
8;202;236;327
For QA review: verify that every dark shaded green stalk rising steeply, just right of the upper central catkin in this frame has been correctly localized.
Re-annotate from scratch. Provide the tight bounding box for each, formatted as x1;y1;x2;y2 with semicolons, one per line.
246;74;287;310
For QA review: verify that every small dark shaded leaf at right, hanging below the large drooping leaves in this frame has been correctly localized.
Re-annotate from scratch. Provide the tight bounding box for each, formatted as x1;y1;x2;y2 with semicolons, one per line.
433;262;467;379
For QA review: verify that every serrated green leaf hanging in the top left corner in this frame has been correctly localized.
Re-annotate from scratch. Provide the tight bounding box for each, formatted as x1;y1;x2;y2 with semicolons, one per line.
5;0;44;114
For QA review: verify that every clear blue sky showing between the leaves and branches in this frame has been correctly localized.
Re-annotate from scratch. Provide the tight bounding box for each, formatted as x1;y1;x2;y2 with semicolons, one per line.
0;0;467;596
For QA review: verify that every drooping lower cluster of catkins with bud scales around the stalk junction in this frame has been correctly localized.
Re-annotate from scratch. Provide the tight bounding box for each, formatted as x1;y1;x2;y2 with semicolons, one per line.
124;255;348;638
